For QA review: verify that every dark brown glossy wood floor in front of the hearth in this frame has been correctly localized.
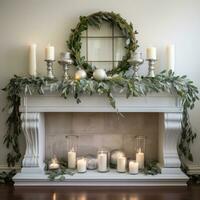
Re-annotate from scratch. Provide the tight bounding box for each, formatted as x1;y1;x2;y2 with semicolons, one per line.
0;185;200;200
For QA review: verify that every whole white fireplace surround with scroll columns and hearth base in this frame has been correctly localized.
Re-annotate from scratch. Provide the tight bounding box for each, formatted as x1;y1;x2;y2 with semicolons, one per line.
14;93;188;186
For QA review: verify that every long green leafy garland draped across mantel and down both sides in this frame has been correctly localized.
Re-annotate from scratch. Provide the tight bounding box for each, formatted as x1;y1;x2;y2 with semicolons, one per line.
3;70;199;166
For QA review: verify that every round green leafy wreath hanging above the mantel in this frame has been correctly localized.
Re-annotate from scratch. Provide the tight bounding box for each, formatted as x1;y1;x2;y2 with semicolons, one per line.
67;12;138;76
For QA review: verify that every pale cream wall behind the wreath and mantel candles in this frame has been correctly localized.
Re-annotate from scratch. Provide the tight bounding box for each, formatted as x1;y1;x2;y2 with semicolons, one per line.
0;0;200;169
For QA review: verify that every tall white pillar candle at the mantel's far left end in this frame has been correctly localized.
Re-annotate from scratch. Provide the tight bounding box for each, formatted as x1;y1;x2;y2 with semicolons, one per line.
29;44;37;76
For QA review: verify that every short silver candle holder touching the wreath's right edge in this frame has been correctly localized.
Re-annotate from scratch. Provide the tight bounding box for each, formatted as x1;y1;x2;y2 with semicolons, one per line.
128;52;144;78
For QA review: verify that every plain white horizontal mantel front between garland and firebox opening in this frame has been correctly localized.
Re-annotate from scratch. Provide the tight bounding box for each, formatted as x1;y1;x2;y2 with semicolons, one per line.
20;93;182;112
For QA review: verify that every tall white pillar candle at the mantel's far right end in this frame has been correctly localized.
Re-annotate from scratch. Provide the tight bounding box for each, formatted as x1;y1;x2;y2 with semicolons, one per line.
166;44;175;71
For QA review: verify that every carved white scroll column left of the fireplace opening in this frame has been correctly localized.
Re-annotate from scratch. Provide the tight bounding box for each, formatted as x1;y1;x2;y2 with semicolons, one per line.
21;113;45;173
